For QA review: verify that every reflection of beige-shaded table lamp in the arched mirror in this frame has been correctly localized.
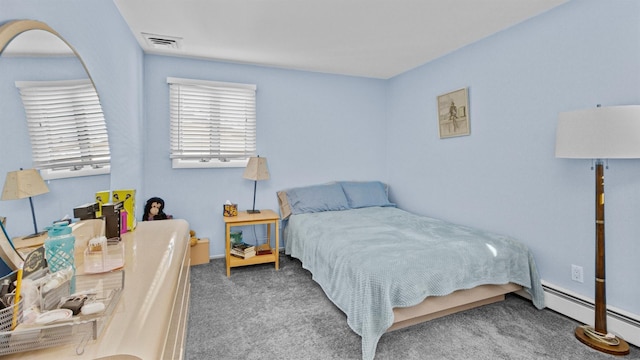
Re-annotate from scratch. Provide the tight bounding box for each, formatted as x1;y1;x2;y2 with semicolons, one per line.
2;168;49;239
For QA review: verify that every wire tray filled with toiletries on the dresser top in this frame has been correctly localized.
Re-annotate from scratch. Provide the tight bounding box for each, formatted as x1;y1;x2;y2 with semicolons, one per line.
0;267;124;356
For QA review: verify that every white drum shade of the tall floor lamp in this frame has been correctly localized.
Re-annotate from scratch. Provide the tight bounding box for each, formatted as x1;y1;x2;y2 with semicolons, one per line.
556;105;640;159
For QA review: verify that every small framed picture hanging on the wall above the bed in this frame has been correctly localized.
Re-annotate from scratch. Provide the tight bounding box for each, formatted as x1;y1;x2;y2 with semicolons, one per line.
438;87;471;139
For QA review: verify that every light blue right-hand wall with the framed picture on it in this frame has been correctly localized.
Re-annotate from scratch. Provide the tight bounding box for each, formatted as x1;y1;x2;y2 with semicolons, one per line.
387;0;640;314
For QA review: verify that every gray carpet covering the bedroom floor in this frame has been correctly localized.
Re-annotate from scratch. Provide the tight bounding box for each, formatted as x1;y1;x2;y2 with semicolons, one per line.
186;255;640;360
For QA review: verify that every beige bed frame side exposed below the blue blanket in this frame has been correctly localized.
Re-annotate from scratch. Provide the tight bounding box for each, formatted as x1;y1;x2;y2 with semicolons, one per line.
387;283;522;332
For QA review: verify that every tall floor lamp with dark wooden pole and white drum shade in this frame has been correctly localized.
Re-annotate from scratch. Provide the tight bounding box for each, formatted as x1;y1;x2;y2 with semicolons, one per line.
556;105;640;355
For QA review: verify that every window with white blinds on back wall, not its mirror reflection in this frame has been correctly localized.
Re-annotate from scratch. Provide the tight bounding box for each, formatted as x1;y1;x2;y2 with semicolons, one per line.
167;78;256;168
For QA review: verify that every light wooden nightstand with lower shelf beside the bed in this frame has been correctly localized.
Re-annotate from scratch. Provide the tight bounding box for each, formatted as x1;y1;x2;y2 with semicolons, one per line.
223;210;280;276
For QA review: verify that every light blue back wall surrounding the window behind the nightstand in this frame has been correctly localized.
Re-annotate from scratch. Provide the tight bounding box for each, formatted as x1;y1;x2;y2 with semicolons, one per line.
144;55;386;255
